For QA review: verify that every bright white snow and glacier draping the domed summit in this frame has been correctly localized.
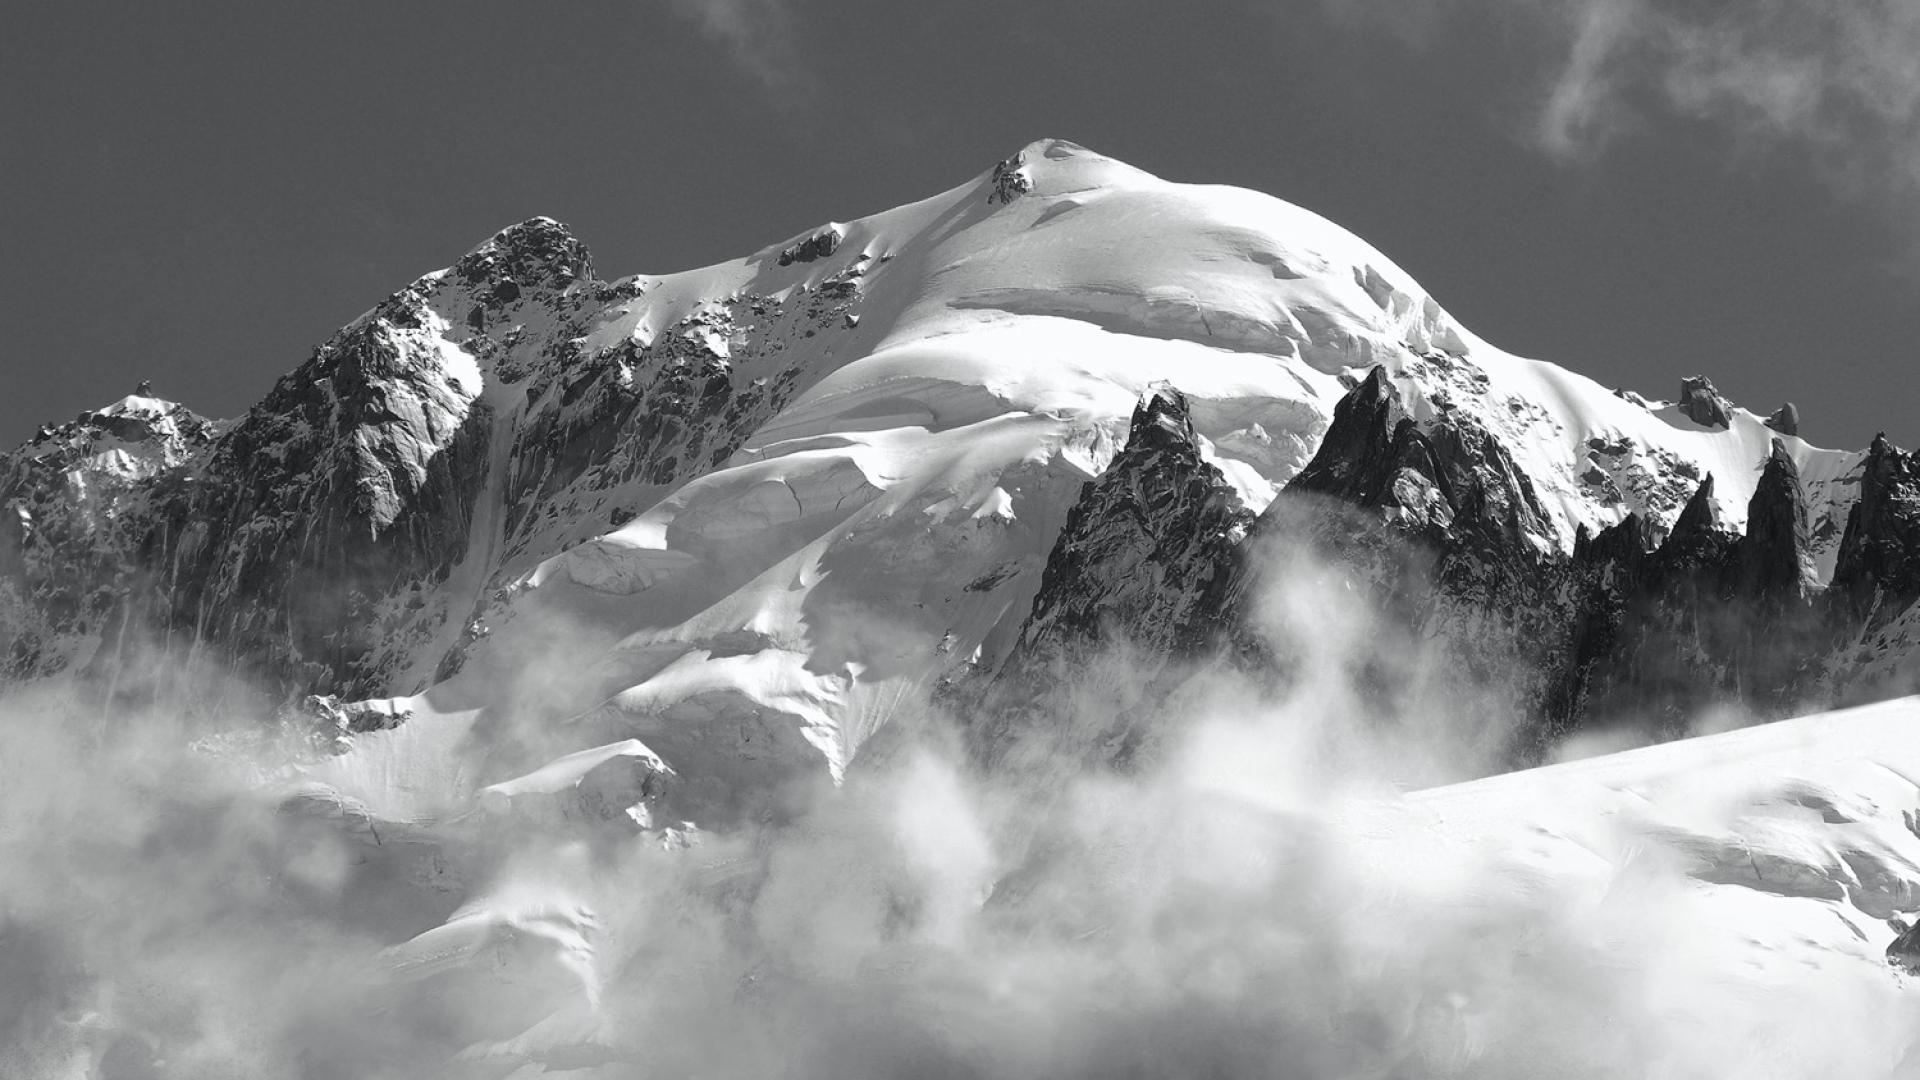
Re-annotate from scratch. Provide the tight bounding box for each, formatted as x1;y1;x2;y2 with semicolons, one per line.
291;140;1860;834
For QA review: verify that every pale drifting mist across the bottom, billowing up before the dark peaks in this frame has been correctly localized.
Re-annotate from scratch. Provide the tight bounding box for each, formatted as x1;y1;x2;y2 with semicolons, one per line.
0;549;1920;1080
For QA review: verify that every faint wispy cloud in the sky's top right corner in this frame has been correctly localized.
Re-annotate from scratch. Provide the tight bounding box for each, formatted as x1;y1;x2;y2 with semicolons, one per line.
1327;0;1920;194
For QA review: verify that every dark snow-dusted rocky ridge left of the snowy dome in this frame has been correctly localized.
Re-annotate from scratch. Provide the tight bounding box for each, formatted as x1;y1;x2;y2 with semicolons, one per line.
0;217;591;700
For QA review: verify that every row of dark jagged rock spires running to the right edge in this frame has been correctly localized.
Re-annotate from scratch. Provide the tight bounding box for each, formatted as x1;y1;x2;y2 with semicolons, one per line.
1012;369;1920;763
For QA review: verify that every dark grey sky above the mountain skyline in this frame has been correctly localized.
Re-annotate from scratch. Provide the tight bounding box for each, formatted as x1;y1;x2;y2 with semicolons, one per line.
0;0;1920;446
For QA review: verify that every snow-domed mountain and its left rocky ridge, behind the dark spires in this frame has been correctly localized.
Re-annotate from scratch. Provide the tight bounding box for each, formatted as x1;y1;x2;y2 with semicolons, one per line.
0;142;1912;773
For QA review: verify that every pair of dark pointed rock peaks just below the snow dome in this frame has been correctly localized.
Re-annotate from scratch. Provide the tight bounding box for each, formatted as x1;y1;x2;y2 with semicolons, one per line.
977;369;1561;763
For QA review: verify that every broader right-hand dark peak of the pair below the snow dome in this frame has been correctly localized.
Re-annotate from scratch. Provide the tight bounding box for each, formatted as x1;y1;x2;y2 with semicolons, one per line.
1231;361;1563;749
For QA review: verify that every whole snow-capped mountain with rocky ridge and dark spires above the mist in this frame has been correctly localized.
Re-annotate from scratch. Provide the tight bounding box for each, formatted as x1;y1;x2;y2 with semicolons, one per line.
11;140;1920;1074
